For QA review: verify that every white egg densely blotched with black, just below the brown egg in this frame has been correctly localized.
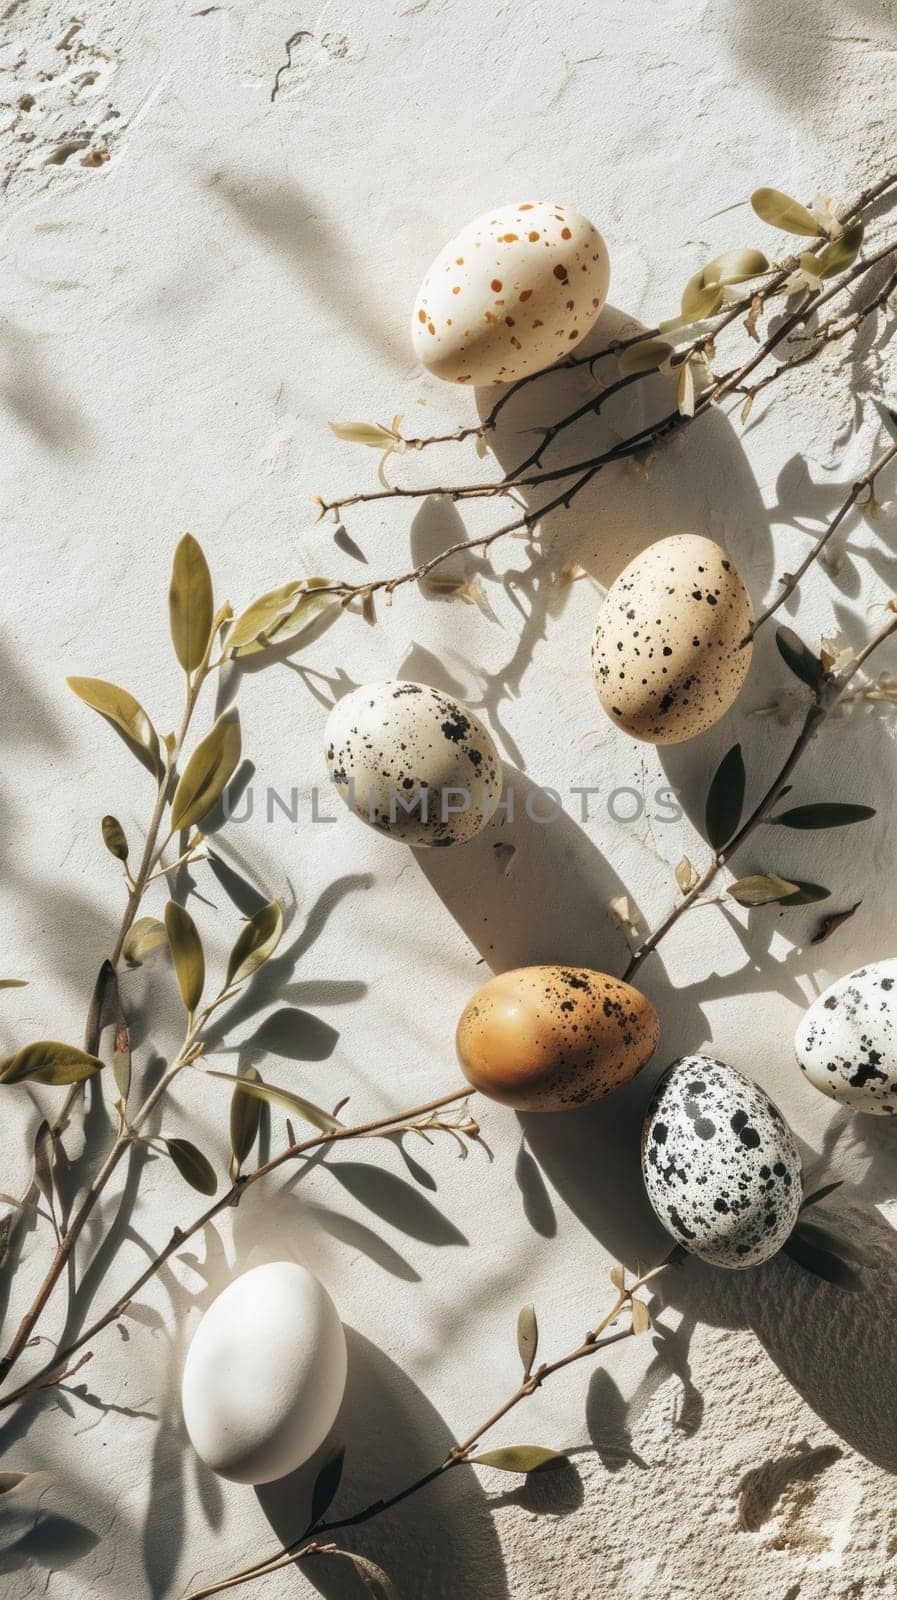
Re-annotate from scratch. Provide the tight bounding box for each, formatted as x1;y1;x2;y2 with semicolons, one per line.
641;1056;801;1267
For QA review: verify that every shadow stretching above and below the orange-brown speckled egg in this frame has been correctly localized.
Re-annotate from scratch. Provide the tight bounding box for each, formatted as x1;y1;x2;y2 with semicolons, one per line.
414;765;708;1262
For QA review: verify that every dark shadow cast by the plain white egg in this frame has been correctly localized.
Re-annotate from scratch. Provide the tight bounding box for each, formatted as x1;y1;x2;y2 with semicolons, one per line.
256;1328;510;1600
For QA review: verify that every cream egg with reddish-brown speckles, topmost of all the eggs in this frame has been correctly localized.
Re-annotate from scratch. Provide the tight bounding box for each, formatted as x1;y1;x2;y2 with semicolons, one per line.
411;200;611;384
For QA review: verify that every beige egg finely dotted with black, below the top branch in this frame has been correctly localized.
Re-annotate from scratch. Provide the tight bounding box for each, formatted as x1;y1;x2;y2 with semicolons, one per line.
592;533;753;744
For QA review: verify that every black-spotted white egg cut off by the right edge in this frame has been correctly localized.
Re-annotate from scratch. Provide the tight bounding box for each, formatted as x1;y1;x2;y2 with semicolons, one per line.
795;957;897;1117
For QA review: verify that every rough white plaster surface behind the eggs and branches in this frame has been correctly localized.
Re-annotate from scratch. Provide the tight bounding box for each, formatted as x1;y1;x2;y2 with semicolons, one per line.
0;0;897;1600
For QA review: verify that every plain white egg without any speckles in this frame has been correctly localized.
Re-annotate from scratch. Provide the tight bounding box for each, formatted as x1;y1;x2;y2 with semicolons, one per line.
181;1261;345;1483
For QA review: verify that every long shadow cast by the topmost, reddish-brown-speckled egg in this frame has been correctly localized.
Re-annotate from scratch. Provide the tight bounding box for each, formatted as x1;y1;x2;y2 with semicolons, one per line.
470;306;782;790
